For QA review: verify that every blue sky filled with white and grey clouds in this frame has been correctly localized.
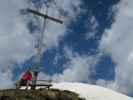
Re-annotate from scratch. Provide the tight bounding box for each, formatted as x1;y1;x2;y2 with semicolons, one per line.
0;0;133;96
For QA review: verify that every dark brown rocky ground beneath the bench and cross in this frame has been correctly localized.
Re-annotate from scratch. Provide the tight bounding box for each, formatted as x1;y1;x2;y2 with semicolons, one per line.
0;89;84;100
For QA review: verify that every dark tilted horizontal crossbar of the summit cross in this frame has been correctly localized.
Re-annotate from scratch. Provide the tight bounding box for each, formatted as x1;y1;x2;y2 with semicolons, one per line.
27;9;63;24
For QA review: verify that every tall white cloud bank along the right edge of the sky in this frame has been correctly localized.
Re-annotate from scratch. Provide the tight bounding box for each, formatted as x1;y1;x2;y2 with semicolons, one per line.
100;0;133;93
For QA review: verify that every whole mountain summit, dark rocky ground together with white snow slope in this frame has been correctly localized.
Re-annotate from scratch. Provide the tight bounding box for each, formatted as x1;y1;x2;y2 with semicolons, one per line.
0;82;133;100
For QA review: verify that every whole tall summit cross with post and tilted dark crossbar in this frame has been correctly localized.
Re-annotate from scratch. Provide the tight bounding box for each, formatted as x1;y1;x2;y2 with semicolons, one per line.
27;9;63;89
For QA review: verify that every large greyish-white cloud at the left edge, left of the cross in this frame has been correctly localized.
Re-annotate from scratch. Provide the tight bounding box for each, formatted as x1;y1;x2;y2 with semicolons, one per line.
0;0;34;88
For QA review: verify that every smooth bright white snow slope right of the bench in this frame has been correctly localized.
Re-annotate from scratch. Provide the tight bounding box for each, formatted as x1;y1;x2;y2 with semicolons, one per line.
52;82;133;100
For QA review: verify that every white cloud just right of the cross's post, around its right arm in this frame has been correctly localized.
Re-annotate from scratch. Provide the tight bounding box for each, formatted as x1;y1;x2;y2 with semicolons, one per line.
37;0;83;48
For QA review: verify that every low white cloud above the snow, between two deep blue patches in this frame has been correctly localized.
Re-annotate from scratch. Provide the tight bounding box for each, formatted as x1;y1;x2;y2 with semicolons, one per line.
53;47;97;82
